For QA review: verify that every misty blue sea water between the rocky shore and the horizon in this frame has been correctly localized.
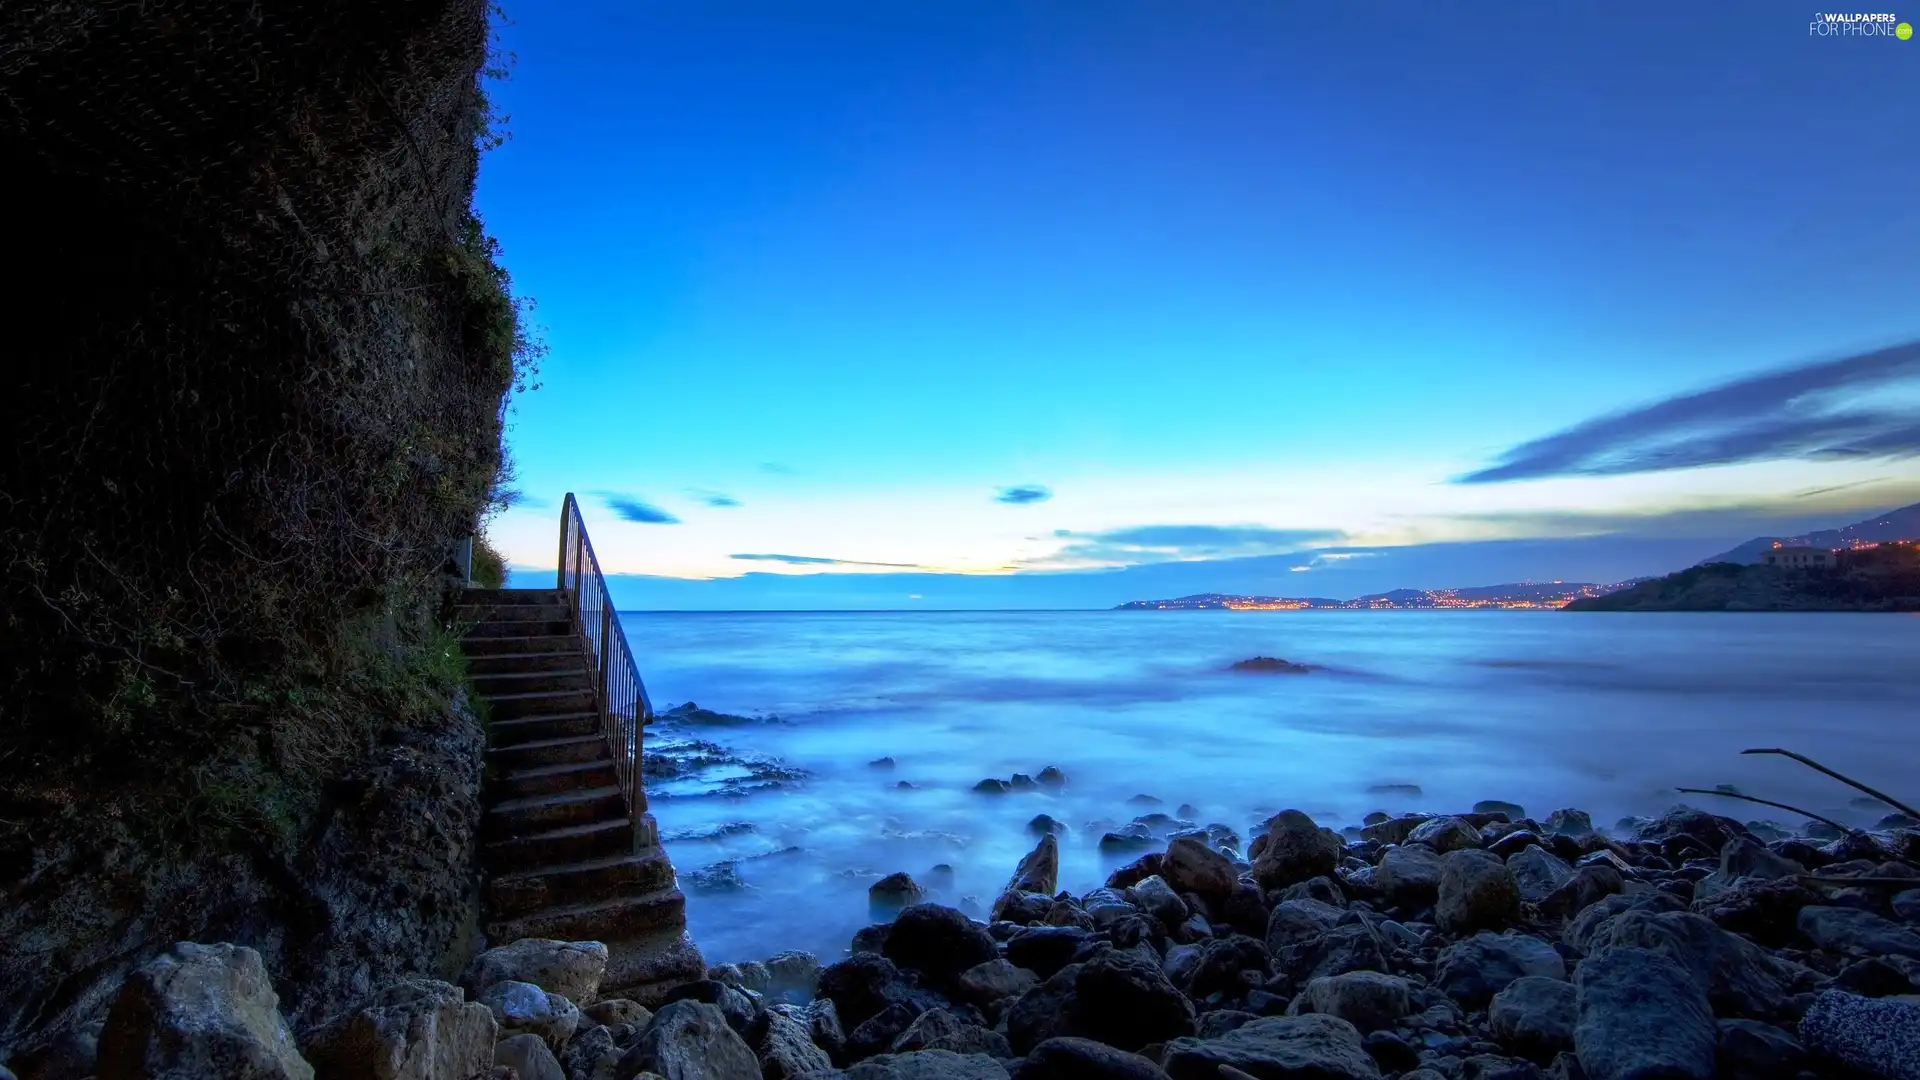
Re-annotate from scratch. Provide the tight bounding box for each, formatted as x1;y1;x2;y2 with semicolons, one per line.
622;611;1920;963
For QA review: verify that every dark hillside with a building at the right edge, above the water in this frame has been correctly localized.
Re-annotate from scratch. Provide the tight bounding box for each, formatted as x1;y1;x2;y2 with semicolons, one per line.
1567;544;1920;611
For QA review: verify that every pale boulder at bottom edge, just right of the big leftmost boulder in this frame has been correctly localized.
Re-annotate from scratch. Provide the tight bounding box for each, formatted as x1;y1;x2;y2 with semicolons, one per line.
301;978;499;1080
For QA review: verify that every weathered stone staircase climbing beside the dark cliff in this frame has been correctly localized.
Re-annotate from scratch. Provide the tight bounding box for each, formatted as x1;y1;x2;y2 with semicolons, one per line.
459;588;707;1005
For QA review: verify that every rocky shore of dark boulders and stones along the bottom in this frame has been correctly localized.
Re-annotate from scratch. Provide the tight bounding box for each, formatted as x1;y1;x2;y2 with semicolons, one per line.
22;791;1920;1080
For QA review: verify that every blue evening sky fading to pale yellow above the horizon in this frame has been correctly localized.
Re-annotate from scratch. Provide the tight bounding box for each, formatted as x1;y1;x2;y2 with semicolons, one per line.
478;0;1920;607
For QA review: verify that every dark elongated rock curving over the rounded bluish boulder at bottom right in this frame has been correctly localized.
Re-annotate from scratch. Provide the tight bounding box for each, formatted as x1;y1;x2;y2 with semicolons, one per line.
1590;911;1799;1019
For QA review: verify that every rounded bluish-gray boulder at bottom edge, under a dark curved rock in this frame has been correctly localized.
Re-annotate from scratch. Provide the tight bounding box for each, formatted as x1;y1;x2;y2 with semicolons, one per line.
1572;945;1718;1080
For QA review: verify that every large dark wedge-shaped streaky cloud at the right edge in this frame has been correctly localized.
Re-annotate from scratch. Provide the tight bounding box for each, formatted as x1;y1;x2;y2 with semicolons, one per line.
1455;342;1920;484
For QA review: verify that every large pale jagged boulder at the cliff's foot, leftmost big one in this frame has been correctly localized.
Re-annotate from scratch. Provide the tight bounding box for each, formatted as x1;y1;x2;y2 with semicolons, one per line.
98;942;313;1080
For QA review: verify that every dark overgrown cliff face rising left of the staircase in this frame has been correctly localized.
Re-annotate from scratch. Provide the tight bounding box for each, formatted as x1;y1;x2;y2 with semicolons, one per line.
0;0;524;1076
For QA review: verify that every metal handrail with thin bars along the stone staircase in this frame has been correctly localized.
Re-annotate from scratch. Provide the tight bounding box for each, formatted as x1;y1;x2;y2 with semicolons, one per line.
559;492;653;842
